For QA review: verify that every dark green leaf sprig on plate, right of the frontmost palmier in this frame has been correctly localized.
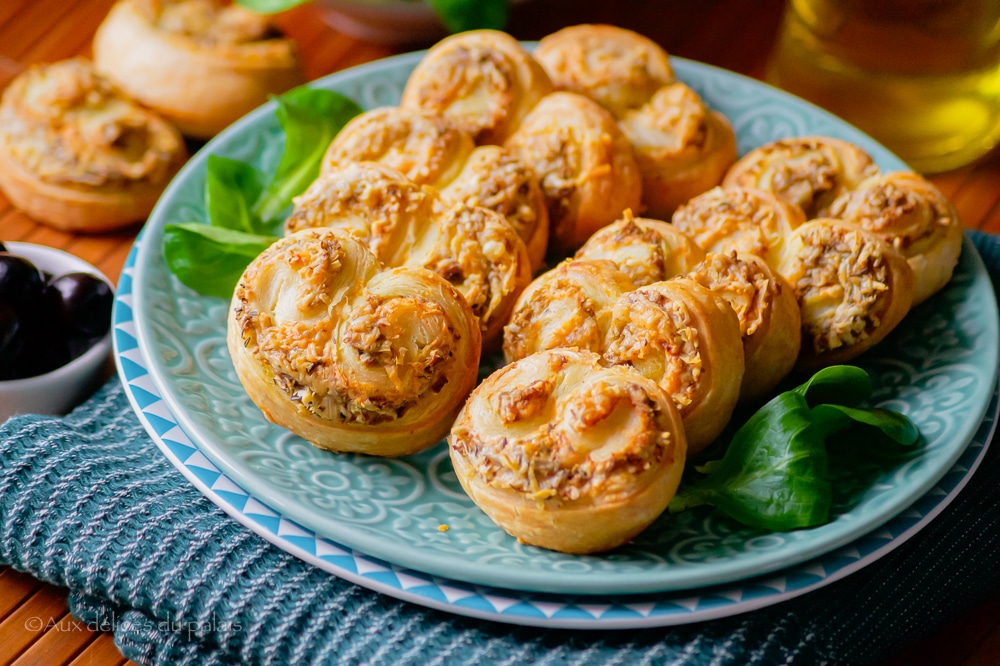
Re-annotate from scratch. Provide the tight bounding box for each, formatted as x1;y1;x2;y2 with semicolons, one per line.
669;366;920;531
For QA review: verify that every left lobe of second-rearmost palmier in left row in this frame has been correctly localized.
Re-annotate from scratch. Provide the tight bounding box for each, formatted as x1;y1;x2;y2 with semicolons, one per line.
400;30;552;144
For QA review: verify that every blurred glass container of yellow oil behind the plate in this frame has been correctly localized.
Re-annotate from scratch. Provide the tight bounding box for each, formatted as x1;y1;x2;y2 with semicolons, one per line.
767;0;1000;173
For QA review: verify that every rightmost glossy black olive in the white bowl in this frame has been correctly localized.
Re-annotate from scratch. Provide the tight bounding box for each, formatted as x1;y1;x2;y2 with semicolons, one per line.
44;273;114;336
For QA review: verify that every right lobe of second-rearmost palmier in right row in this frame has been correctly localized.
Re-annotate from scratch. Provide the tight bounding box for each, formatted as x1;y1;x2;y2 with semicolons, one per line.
779;218;913;370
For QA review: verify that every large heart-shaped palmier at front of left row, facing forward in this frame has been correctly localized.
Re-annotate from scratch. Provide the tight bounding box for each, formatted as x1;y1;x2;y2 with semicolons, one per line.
227;229;480;456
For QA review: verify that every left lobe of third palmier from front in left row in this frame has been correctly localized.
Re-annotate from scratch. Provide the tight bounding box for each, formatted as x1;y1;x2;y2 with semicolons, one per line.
321;107;475;189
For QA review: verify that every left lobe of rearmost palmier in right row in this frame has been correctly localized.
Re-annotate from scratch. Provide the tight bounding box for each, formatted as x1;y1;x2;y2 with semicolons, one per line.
722;136;878;219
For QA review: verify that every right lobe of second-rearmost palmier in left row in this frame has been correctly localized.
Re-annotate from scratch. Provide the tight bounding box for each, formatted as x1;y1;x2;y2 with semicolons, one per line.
507;92;642;250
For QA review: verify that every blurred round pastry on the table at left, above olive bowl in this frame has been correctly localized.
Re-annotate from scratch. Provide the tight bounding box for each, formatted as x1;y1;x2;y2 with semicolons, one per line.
0;58;187;232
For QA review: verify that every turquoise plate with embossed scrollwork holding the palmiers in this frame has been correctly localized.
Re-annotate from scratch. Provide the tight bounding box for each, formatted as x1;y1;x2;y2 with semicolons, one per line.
133;54;998;594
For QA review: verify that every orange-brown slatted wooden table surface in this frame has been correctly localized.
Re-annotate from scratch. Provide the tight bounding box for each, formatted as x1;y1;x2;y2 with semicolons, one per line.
0;0;1000;666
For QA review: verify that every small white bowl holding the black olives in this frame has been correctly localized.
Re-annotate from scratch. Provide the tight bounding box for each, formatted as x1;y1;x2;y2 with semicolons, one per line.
0;242;114;423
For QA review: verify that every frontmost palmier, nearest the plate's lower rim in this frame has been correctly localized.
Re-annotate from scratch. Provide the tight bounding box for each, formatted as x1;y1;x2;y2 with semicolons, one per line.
448;349;686;554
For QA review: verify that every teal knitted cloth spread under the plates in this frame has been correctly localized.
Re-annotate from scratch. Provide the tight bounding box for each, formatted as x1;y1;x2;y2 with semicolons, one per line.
0;234;1000;666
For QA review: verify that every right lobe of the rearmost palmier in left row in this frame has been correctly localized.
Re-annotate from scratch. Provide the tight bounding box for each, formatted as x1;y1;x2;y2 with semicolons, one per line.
618;82;736;219
